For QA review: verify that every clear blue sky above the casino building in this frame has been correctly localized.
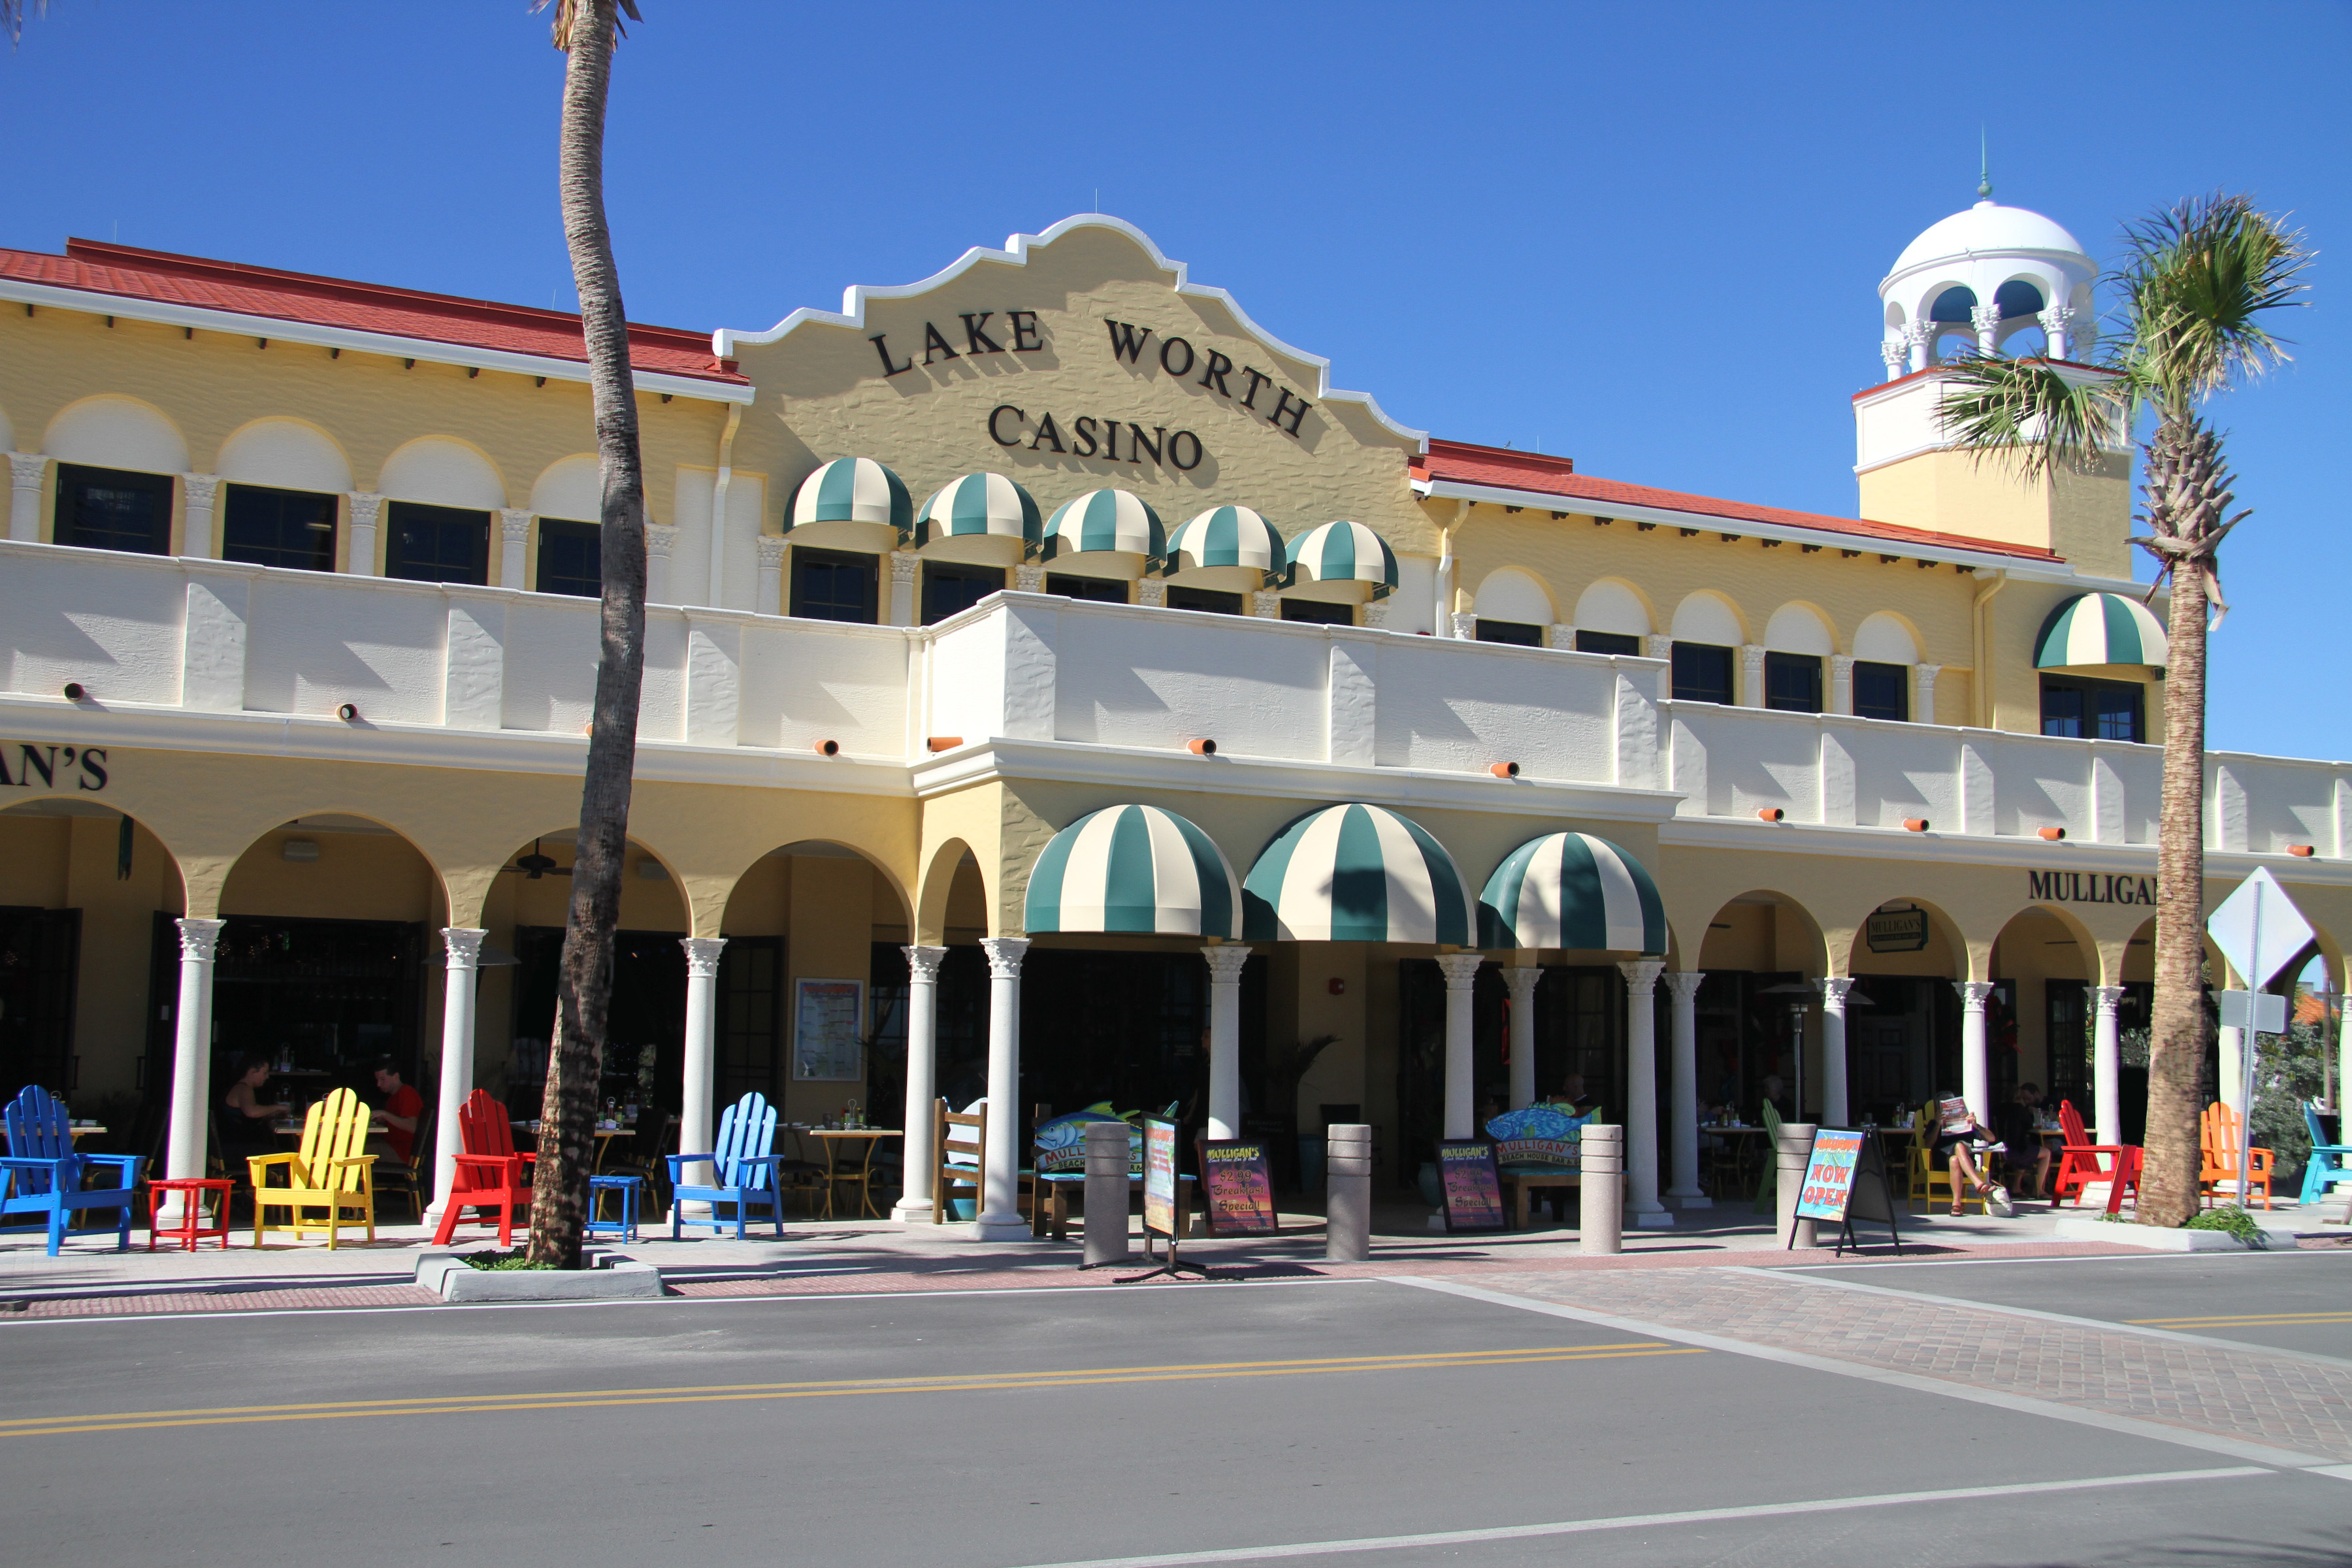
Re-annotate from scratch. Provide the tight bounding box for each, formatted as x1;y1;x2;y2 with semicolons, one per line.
0;0;2352;757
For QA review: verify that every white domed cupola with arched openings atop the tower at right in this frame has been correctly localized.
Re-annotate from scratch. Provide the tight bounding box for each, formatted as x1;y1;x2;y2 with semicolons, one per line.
1879;181;2098;381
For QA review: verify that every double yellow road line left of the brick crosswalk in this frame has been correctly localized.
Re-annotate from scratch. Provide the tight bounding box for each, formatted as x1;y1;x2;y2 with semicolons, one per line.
0;1340;1705;1437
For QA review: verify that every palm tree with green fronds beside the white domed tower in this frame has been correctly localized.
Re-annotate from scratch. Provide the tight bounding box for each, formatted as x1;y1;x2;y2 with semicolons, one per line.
1940;195;2312;1225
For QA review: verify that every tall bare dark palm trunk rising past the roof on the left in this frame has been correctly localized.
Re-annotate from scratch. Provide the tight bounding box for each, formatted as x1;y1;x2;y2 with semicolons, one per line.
529;0;644;1269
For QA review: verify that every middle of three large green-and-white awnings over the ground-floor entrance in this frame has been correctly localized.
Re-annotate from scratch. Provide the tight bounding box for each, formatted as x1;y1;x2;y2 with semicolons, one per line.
1242;804;1475;947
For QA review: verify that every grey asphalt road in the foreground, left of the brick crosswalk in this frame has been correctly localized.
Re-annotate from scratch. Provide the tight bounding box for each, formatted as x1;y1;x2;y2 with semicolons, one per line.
0;1262;2352;1568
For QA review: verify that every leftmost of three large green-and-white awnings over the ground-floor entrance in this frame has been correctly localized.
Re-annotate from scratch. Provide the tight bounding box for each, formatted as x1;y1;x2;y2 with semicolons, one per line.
1023;806;1242;936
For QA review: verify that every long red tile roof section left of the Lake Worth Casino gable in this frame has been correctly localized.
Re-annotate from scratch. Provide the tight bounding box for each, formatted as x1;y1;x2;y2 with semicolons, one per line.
0;240;748;385
